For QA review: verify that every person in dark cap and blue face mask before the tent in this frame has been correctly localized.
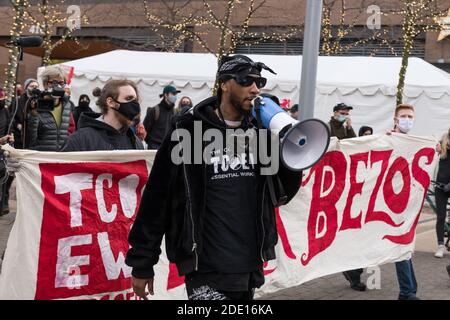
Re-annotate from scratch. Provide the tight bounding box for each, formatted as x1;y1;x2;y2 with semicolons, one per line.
144;86;181;150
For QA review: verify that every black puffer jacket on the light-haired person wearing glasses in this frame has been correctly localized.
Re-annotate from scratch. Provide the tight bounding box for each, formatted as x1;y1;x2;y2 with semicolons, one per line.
25;98;72;151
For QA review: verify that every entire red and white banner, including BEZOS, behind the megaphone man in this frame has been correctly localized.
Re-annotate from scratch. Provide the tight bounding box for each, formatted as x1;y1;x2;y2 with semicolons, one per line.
0;134;437;299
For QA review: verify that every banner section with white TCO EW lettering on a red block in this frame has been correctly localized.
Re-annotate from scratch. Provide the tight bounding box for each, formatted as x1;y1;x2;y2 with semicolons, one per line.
0;150;154;300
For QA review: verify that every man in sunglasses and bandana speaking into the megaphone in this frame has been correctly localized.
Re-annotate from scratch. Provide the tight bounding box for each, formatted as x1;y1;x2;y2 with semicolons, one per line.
126;55;302;300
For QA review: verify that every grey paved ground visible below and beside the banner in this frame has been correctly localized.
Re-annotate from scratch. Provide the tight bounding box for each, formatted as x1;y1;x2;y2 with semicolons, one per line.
0;184;450;300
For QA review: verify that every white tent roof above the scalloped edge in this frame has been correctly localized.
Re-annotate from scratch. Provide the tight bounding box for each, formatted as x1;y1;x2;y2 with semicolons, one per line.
52;50;450;95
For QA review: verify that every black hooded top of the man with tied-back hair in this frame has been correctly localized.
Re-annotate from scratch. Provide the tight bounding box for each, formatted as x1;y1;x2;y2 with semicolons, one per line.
61;113;144;152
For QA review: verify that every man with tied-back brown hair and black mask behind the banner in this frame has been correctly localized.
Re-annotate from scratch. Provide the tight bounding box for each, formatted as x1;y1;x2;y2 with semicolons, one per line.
61;80;144;152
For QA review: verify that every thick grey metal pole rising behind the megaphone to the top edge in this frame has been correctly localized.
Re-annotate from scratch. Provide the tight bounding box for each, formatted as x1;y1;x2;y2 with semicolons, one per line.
299;0;322;120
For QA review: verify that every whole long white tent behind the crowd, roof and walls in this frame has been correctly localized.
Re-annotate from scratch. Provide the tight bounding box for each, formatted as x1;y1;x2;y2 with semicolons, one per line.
39;50;450;136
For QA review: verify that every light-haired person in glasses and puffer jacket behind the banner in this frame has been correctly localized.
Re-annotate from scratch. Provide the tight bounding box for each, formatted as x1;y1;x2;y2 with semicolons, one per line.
25;66;74;151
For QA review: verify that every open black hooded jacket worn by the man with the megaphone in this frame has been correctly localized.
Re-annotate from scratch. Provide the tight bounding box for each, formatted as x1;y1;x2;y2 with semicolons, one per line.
126;97;302;278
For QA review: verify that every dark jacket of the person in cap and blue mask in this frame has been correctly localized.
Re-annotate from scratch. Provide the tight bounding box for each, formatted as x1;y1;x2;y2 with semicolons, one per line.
143;99;175;149
